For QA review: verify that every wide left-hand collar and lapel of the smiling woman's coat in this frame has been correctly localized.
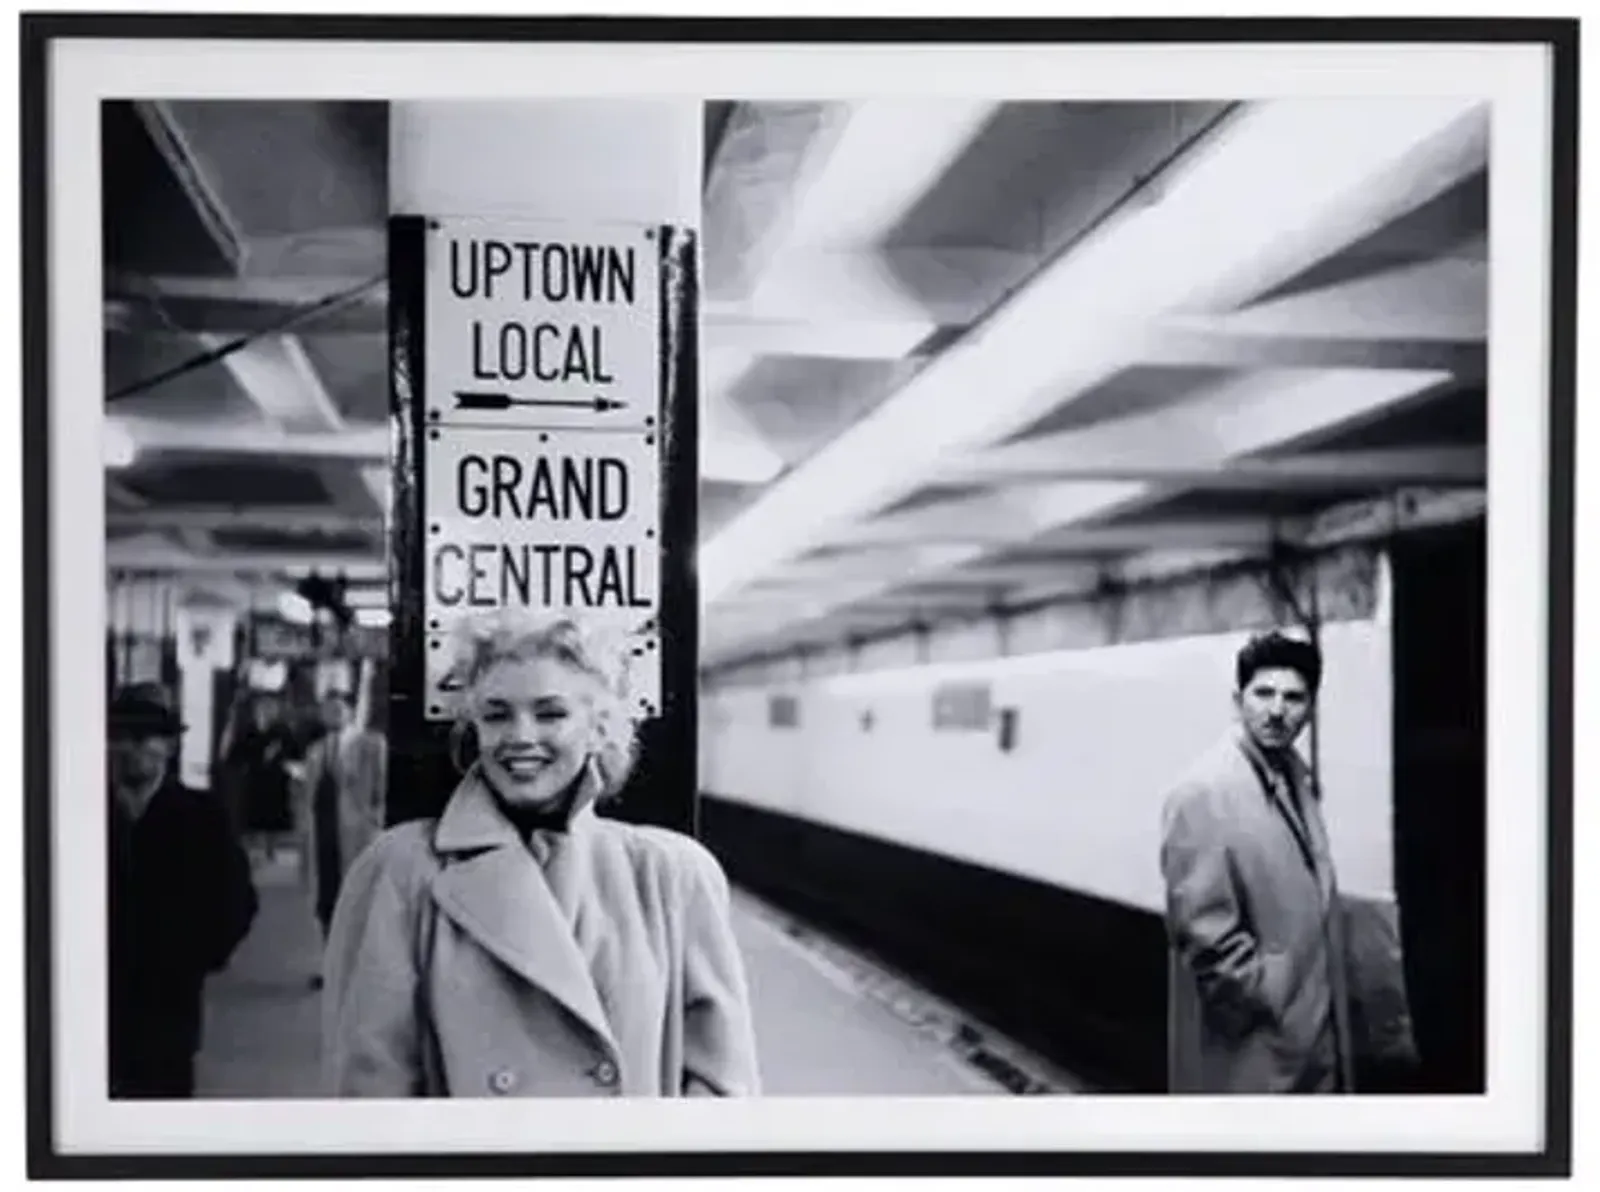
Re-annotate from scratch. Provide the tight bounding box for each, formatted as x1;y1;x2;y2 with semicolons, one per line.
434;774;616;1048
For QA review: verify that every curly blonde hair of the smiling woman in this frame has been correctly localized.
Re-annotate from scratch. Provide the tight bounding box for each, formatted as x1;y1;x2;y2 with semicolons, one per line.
450;610;638;797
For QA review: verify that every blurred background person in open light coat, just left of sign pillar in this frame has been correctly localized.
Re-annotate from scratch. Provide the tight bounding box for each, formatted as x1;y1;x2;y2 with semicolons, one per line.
301;691;389;987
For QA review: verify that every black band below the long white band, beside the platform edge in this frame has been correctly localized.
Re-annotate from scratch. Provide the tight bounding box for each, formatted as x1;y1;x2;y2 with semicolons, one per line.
699;794;1166;1093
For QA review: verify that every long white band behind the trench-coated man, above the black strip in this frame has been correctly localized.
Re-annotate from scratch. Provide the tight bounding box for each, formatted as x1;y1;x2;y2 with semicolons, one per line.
701;621;1394;912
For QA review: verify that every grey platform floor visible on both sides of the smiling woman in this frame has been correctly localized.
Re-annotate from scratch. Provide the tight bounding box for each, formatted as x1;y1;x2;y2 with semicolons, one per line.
197;851;1075;1099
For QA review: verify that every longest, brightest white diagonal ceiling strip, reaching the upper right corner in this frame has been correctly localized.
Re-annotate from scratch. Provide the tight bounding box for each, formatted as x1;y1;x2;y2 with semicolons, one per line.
698;99;1488;603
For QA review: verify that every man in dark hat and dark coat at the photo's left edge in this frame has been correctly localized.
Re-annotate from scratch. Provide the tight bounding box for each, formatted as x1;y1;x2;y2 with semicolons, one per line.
107;683;256;1098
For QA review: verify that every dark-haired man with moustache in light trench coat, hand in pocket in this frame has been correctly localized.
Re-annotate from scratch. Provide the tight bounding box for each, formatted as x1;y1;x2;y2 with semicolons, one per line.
1162;634;1354;1093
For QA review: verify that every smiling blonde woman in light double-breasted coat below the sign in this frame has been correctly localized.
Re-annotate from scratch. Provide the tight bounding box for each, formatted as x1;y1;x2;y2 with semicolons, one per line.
323;614;758;1098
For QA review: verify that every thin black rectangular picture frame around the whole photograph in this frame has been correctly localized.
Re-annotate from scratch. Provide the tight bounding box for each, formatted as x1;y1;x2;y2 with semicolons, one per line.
21;13;1579;1179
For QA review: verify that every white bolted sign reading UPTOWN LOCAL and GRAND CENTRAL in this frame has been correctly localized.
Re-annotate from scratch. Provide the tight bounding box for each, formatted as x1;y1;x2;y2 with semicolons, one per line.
422;219;661;720
